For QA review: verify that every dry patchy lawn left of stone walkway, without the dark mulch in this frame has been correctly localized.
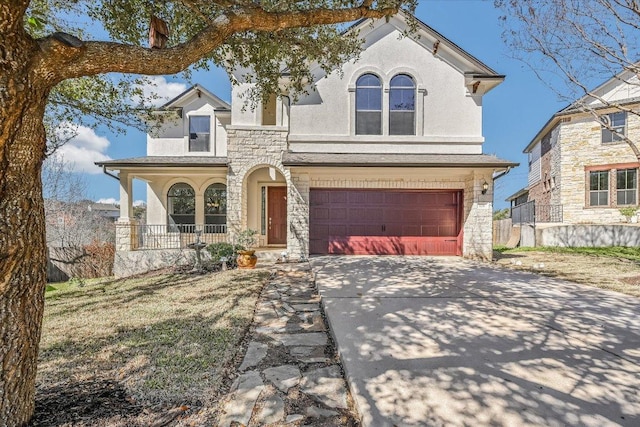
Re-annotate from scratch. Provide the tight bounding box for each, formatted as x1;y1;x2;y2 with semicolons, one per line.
38;270;268;422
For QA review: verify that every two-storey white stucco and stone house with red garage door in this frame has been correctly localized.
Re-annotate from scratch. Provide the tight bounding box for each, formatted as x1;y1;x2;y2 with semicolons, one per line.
97;14;517;259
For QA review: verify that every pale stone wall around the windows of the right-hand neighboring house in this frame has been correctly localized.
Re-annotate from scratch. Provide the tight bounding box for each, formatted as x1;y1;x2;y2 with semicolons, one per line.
560;114;640;224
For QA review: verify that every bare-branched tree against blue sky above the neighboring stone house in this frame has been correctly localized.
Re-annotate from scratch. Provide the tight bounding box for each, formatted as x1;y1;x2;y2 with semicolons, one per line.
495;0;640;159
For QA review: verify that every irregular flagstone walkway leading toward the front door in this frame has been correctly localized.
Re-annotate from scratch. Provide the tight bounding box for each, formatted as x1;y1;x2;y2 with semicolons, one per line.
218;263;359;427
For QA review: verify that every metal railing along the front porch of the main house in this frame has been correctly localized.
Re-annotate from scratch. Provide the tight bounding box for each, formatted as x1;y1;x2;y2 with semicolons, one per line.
121;224;227;250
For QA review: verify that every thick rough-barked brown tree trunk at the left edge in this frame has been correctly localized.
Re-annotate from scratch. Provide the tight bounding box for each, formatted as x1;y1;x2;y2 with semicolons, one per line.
0;29;49;426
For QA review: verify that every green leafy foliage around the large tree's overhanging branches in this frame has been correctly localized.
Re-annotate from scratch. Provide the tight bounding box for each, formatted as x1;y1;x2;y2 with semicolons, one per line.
25;0;417;146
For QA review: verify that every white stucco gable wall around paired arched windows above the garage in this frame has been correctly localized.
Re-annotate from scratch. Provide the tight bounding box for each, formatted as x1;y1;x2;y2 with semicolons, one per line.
290;20;483;152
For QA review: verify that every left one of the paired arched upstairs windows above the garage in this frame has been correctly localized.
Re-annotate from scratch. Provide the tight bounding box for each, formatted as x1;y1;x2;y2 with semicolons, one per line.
356;74;382;135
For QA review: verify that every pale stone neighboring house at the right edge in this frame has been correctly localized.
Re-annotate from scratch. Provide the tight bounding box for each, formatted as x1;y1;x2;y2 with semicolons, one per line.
507;72;640;224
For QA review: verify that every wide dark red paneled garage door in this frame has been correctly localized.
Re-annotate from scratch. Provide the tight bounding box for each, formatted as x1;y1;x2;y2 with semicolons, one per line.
309;189;462;255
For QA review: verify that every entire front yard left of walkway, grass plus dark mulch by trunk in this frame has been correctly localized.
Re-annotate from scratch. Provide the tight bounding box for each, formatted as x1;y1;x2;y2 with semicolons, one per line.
31;269;269;426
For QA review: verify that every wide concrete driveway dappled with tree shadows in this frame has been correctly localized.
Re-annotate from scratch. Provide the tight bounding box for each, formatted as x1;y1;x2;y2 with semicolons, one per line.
311;256;640;427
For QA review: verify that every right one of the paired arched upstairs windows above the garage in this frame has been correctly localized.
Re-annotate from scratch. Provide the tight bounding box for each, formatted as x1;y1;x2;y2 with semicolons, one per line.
389;74;416;135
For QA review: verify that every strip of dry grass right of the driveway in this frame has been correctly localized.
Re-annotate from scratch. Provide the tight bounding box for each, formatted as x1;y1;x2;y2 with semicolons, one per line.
494;248;640;297
